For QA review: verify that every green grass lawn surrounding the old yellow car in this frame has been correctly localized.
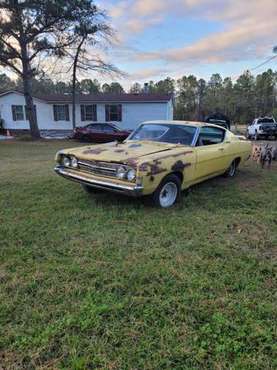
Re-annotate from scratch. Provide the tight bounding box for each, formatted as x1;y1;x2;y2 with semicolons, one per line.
0;141;277;370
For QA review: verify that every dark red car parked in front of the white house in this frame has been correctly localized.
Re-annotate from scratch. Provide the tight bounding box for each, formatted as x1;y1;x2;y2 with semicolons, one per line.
72;123;131;143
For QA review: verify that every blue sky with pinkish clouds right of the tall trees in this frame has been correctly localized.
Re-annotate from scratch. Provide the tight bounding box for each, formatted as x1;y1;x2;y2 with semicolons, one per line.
95;0;277;88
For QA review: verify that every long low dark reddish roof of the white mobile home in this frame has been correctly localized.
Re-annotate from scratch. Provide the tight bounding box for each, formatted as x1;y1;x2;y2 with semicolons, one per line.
0;90;172;103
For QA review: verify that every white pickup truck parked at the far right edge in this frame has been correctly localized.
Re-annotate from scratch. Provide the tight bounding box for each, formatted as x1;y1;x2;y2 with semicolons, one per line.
246;117;277;140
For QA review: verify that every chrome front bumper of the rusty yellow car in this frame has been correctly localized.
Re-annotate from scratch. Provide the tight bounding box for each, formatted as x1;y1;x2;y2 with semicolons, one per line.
54;166;143;197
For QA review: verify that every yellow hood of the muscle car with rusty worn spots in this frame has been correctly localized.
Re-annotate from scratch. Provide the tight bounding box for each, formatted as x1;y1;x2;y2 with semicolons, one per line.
62;141;184;163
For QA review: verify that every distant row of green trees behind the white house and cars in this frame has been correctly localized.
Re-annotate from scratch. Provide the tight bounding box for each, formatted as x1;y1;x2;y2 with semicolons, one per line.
0;69;277;123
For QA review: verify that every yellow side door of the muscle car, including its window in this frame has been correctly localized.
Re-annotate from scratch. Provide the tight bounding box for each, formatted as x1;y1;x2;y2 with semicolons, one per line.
195;126;228;179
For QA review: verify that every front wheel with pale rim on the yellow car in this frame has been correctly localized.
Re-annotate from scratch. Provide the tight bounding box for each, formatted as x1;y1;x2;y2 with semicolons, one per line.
152;174;181;208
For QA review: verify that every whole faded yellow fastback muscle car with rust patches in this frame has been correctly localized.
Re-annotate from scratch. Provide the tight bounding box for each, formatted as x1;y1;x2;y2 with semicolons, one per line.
55;121;251;208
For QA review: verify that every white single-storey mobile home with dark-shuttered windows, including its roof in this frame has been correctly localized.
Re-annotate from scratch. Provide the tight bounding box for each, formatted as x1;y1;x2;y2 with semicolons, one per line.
0;91;173;132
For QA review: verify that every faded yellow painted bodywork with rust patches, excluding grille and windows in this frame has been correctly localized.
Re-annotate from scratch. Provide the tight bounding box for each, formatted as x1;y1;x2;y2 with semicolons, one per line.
56;122;251;195
